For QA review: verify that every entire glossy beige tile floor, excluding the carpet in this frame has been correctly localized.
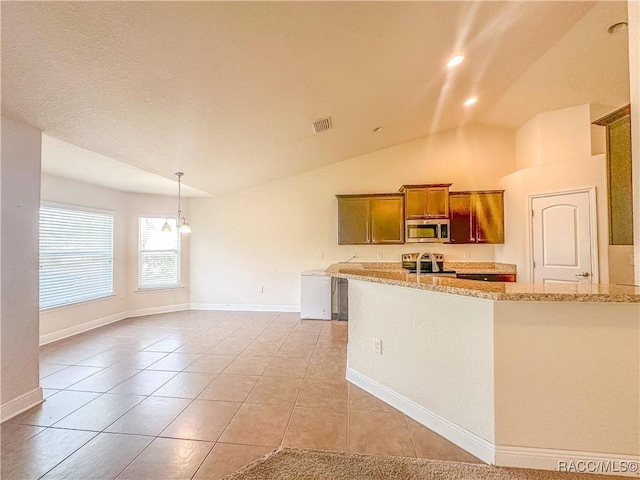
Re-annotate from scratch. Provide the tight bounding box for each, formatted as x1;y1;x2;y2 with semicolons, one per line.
1;311;478;480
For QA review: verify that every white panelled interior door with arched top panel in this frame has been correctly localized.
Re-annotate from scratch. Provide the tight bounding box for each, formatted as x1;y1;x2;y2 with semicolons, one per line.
531;191;597;286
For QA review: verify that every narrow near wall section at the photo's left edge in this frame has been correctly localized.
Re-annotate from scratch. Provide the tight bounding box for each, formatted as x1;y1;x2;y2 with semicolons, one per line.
0;117;42;420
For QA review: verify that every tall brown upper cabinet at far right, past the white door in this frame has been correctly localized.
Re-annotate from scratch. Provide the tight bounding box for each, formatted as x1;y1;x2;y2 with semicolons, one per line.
593;105;633;245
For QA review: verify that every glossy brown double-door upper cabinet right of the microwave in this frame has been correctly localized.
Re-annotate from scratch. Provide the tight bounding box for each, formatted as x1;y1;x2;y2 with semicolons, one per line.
449;190;504;243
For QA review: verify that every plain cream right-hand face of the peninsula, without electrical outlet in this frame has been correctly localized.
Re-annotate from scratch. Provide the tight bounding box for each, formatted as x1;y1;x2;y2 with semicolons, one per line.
494;302;640;459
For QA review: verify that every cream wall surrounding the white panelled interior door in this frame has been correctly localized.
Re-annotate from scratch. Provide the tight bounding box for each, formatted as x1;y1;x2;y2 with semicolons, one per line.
496;105;609;283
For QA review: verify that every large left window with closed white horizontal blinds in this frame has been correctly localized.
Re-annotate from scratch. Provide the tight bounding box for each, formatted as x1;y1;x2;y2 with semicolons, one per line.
40;206;113;310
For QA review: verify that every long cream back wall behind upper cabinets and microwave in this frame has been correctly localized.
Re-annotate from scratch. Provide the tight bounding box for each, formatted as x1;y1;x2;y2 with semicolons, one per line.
190;125;515;309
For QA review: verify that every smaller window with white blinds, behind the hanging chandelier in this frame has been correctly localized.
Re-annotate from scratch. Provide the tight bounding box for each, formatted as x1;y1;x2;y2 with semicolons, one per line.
138;217;180;290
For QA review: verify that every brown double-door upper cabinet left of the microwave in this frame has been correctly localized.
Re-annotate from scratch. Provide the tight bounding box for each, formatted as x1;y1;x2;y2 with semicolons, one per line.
336;193;404;245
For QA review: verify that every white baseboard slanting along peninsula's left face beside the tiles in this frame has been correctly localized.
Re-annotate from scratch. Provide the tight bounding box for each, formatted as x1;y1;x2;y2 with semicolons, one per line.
347;367;495;464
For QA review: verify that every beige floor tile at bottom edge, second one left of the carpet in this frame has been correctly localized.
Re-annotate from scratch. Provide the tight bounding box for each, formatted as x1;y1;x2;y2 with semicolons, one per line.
118;438;213;480
